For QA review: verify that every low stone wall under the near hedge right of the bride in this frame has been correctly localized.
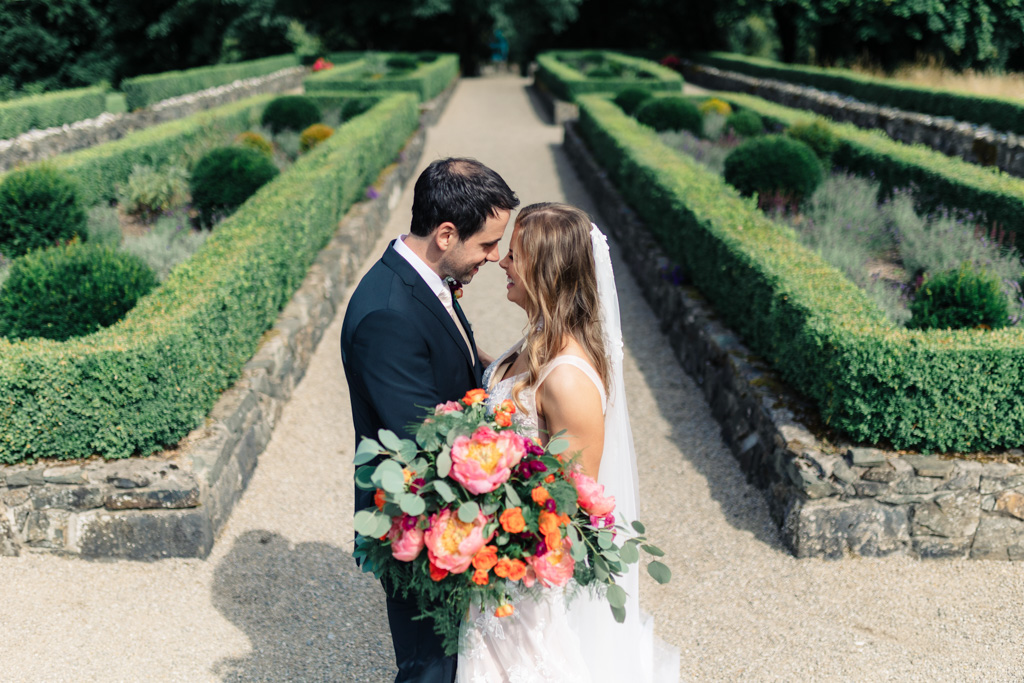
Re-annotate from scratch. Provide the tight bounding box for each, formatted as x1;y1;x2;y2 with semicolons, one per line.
564;123;1024;560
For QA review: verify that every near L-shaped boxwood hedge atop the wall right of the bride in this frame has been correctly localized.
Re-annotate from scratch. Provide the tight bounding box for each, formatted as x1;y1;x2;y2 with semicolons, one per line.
580;95;1024;452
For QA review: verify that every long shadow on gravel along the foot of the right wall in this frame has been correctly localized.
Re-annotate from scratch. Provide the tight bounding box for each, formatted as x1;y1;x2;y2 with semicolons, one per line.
552;144;788;554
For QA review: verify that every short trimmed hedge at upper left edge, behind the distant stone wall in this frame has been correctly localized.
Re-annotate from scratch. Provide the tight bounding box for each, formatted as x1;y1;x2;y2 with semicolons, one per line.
0;87;106;140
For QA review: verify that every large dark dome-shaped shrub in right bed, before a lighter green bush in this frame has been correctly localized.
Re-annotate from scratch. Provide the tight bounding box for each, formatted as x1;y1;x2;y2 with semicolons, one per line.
722;135;823;208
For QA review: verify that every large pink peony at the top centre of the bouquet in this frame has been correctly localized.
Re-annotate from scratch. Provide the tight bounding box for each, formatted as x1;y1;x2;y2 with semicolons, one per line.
450;426;526;495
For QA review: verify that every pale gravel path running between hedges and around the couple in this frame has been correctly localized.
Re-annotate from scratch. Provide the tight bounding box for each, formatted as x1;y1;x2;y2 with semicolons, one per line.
0;76;1024;682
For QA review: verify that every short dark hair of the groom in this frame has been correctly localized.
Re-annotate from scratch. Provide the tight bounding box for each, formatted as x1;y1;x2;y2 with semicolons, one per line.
411;159;519;240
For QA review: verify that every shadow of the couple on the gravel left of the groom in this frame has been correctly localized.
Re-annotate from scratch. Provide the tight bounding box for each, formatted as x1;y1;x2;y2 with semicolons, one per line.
213;530;395;682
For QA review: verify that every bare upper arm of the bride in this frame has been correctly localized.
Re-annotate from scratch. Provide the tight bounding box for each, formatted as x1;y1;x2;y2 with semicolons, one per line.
537;365;604;481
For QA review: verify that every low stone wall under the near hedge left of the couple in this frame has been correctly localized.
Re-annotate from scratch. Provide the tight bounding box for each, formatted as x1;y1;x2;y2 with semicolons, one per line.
0;84;455;560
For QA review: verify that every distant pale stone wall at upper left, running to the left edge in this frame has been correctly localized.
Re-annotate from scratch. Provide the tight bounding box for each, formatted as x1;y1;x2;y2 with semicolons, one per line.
0;67;308;172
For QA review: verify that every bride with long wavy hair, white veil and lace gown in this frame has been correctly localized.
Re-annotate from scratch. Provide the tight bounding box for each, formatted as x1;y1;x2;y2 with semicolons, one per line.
457;204;679;683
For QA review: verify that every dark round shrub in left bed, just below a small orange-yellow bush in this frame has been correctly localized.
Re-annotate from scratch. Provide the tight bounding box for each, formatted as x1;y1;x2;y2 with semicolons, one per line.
190;147;279;226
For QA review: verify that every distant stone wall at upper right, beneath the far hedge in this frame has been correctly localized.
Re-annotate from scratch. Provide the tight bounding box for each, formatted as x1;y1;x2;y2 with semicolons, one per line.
683;61;1024;177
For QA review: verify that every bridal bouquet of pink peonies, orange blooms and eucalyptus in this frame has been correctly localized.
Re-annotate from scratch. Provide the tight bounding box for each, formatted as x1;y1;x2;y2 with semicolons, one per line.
354;389;671;654
